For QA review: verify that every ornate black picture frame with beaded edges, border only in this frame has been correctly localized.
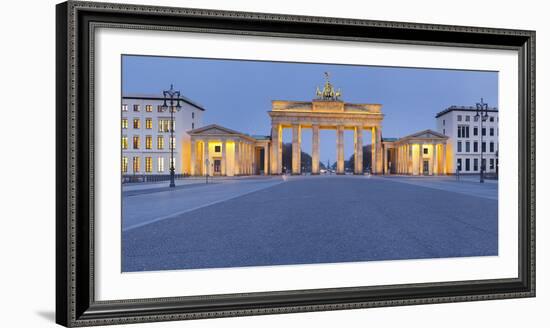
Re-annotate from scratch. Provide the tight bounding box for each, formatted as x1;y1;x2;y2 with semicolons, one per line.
56;1;535;326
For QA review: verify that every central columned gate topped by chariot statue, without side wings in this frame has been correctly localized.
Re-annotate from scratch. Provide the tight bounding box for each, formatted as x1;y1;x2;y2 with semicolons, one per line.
268;73;384;175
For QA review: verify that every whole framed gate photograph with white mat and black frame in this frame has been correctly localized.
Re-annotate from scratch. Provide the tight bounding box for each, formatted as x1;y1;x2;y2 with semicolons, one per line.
56;1;535;326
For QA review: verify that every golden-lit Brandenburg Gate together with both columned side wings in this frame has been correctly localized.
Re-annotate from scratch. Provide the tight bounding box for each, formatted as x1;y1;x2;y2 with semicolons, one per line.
187;74;454;176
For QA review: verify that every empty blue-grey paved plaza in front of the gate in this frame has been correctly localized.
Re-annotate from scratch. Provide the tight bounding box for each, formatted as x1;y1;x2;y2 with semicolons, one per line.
122;176;498;272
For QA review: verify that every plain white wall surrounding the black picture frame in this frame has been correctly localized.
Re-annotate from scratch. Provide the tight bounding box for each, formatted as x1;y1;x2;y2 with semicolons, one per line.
0;0;550;327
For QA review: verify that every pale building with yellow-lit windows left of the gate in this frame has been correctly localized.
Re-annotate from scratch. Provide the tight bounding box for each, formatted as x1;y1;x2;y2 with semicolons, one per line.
121;95;205;175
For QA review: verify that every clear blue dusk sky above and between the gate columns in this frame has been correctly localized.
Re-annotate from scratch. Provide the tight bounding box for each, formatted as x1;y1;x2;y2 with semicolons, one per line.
122;55;498;163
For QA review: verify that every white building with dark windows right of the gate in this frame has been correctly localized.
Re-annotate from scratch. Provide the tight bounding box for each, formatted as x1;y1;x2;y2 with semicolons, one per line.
436;106;499;174
